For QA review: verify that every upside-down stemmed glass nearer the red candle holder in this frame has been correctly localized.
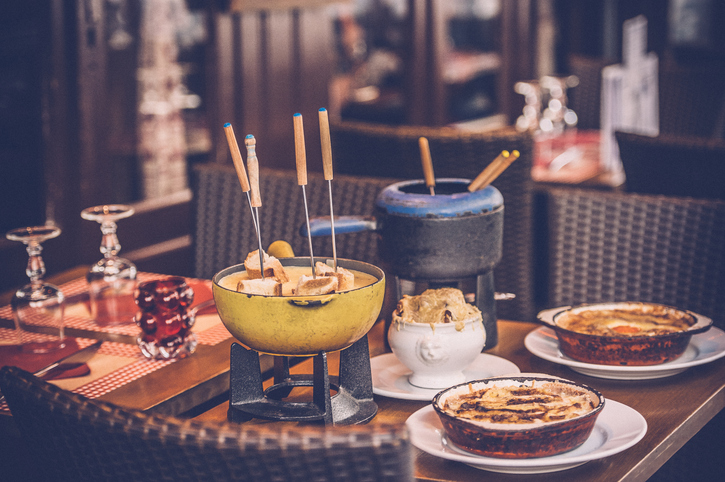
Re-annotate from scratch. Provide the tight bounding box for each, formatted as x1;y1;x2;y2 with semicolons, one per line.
81;204;136;326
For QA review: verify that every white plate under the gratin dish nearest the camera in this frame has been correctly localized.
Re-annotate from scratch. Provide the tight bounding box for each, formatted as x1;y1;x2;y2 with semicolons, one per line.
405;399;647;474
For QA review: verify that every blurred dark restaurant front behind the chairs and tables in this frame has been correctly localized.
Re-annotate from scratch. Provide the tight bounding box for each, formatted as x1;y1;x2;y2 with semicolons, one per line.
0;0;725;290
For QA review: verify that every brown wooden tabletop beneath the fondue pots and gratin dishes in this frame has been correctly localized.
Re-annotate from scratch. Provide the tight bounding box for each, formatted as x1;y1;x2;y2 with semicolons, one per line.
0;271;725;482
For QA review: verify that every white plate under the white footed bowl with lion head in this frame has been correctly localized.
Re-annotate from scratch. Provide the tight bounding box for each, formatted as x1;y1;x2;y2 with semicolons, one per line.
370;353;521;401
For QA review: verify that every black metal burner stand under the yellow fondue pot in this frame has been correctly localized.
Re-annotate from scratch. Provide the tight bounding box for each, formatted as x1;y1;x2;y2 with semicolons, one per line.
227;336;378;425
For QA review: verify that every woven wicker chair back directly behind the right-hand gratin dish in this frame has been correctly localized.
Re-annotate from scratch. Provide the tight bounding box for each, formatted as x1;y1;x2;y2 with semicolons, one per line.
546;188;725;327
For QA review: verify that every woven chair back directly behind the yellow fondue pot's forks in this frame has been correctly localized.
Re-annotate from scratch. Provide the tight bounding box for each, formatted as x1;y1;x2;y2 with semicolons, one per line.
193;164;395;279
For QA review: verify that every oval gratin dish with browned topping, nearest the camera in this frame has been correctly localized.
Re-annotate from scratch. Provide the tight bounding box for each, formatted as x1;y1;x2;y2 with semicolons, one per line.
433;375;605;458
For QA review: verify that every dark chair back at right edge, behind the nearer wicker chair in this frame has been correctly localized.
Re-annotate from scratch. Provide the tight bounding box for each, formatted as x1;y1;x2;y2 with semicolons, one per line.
615;132;725;200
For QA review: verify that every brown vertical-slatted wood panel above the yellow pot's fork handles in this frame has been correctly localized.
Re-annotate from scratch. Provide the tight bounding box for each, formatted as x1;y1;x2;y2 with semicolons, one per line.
210;7;334;171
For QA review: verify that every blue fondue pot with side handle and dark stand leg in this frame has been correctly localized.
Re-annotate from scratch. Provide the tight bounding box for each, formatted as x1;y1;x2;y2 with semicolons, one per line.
300;179;504;348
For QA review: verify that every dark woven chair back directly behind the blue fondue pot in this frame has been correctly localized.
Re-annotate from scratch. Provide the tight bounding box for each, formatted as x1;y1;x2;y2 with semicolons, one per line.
330;122;535;321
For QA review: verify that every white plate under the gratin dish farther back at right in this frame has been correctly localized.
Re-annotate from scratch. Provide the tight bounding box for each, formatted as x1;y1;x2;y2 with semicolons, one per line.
524;326;725;380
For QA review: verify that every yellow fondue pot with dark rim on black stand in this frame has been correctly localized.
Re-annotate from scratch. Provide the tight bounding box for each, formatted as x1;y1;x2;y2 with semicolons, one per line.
212;257;385;356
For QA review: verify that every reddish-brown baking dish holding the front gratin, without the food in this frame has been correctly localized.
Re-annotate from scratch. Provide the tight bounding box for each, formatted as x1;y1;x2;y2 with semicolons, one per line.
432;374;605;459
